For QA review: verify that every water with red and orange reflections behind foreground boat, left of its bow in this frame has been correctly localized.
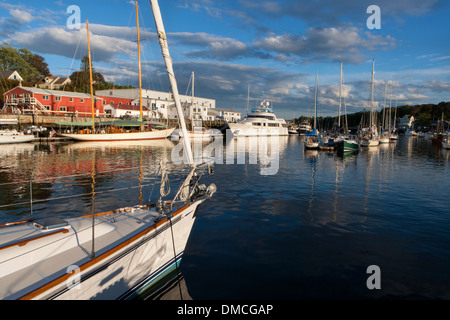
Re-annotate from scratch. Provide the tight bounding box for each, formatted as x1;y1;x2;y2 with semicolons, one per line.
0;140;180;221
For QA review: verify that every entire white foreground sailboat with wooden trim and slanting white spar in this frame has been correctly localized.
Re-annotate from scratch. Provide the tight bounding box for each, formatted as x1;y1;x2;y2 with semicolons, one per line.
0;0;216;300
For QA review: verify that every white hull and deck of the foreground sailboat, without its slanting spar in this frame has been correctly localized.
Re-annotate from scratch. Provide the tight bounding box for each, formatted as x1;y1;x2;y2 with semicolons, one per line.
0;200;203;300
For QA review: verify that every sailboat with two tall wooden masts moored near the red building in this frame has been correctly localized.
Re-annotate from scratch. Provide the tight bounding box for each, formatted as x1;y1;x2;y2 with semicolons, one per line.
56;1;175;141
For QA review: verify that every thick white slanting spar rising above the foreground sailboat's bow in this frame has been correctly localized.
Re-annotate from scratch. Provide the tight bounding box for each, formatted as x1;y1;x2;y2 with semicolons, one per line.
150;0;195;167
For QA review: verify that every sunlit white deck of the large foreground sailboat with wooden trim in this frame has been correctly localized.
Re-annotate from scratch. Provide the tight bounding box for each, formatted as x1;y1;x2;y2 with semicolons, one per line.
0;208;163;299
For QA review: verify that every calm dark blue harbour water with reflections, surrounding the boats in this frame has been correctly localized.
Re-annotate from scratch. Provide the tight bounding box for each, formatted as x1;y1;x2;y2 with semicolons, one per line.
0;136;450;299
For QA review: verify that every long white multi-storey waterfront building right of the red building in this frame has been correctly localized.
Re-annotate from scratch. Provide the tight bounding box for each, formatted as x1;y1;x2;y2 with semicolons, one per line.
96;89;216;120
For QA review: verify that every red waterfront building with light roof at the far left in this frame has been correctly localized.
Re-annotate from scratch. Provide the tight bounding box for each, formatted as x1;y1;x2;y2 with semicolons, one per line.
2;87;103;116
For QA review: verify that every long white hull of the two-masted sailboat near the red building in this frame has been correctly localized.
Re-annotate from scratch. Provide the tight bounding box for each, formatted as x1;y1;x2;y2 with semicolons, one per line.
59;128;174;141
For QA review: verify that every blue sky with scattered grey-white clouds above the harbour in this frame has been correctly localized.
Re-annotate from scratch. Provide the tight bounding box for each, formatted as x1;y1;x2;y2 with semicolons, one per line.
0;0;450;119
